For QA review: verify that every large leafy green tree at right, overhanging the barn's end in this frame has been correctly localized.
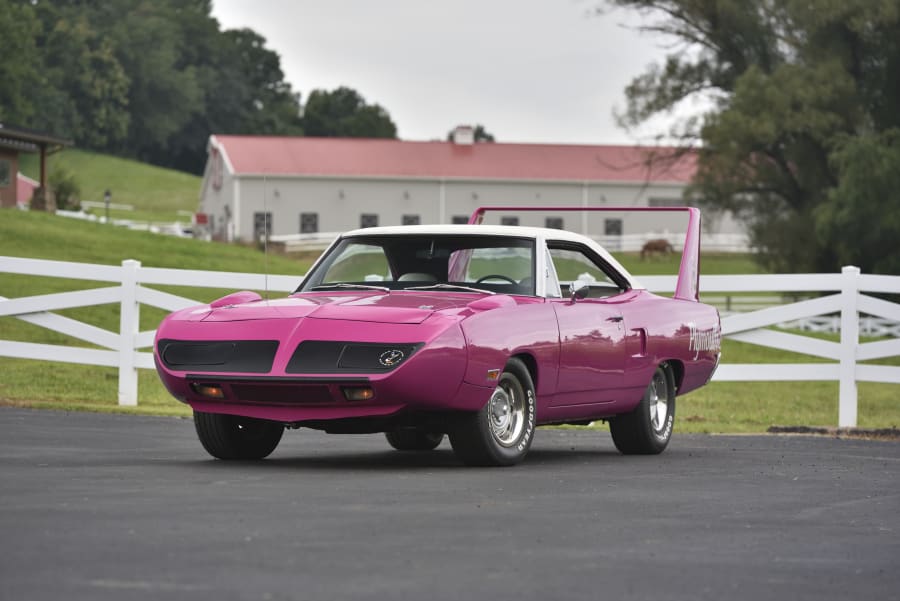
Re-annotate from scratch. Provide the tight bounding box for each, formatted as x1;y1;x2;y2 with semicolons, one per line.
610;0;900;271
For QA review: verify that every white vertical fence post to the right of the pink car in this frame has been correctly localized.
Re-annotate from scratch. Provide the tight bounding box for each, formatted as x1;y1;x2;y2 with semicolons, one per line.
838;266;860;428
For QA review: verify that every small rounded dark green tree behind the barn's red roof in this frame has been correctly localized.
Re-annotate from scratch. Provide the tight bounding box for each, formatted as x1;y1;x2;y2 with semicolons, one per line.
302;87;397;138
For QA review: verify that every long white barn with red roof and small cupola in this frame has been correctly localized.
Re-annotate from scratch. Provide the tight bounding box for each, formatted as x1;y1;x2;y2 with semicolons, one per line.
197;128;741;250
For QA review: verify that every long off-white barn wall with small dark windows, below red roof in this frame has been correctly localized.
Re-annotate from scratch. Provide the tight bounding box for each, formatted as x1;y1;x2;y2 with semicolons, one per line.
200;169;742;241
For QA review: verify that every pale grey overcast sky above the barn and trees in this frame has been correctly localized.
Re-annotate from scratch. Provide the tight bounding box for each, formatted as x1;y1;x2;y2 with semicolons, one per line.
213;0;667;144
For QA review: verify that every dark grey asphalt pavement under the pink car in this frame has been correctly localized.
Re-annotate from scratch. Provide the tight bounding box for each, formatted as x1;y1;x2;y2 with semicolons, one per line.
0;408;900;601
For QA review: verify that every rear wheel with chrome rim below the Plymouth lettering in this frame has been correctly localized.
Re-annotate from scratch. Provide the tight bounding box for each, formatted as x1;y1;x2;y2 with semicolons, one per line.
609;363;675;455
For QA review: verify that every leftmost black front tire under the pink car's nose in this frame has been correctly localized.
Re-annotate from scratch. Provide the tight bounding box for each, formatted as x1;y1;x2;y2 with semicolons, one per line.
194;411;284;459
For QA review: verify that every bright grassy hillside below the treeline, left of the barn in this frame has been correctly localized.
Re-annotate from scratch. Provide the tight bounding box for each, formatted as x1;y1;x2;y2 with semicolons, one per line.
20;148;201;222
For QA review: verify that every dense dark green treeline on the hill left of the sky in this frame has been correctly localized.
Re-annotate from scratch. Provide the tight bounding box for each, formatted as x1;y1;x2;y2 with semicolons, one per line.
0;0;396;173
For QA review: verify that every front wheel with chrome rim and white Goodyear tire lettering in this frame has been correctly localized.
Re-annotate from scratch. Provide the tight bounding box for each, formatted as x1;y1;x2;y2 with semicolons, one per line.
450;359;537;466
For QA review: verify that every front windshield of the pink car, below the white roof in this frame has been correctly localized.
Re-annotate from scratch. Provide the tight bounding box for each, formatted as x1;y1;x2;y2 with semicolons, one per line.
298;234;534;295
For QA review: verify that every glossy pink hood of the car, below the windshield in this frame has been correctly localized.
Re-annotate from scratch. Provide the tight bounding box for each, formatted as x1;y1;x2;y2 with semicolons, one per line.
184;291;484;324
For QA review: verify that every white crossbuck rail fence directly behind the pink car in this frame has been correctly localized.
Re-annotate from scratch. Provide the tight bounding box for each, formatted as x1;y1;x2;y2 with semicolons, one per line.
0;257;900;427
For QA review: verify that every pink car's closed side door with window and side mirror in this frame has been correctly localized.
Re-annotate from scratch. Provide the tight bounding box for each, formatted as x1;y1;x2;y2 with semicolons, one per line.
548;242;630;406
